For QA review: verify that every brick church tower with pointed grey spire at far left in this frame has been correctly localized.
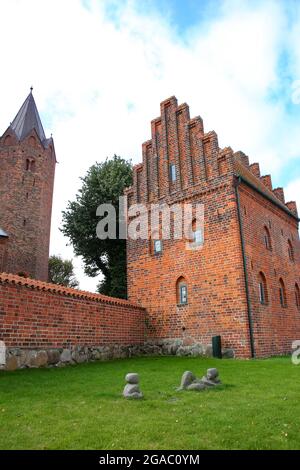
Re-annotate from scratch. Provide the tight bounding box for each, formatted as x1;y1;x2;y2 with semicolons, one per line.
0;89;56;281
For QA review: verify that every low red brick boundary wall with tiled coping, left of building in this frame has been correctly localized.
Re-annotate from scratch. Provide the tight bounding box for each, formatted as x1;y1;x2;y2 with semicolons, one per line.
0;274;145;358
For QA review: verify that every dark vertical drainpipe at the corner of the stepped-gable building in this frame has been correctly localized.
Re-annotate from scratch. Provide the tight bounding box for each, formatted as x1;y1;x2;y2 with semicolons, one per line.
235;177;255;358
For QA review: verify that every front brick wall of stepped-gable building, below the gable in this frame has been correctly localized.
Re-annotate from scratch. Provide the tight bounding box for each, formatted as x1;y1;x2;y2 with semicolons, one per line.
128;186;250;357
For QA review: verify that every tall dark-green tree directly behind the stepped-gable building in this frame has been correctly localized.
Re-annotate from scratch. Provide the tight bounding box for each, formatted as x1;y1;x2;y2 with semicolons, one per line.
61;155;132;298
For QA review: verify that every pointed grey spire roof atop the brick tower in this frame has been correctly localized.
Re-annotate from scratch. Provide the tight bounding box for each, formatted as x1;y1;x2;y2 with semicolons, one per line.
10;87;46;142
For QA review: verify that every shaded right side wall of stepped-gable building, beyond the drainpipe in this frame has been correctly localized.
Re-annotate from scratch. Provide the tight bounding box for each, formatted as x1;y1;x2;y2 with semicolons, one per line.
239;185;300;356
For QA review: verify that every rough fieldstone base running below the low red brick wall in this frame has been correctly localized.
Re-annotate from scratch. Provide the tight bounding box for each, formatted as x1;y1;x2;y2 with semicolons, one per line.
0;339;234;371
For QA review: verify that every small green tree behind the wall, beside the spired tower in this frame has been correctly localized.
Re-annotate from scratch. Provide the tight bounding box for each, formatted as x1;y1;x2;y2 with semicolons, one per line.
49;255;79;289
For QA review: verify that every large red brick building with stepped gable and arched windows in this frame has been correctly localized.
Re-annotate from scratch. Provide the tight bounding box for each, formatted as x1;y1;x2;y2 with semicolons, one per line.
126;97;300;357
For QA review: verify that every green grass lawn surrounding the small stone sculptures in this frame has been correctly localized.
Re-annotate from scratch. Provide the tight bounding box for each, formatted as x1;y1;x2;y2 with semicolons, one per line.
0;357;300;450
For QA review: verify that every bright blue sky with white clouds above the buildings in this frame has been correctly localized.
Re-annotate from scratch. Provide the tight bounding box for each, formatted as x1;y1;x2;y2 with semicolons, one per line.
0;0;300;290
